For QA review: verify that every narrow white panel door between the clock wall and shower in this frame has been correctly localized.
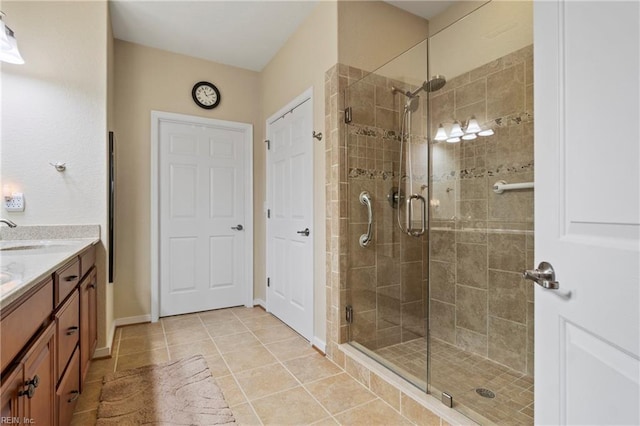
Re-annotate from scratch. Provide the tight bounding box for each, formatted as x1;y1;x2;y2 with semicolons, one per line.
267;96;313;340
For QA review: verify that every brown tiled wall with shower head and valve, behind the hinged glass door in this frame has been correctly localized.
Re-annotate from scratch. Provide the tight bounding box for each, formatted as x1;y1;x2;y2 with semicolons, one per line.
345;67;428;352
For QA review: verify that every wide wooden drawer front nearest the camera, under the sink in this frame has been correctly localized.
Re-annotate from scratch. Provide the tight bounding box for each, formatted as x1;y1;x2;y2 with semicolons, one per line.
0;279;53;371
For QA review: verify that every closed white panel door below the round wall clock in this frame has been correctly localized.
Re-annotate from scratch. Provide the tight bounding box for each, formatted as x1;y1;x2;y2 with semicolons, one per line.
159;121;252;316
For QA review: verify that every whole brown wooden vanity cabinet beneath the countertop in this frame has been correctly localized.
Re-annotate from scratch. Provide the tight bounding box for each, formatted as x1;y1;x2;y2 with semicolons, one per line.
0;241;98;426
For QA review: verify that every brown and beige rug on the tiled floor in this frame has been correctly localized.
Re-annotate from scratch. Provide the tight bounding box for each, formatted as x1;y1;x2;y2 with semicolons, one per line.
97;355;235;426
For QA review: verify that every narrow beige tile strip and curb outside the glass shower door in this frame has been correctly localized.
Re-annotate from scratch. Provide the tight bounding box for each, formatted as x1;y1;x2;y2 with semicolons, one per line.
325;64;450;424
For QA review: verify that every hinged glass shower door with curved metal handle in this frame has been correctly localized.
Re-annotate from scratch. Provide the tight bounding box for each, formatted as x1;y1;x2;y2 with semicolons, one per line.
345;42;428;390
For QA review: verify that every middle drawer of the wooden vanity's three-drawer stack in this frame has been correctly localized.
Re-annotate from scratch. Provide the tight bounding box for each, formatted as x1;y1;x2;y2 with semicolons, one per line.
56;291;80;380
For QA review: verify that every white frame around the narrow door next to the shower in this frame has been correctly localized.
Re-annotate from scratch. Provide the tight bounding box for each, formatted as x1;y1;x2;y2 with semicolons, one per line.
264;87;316;344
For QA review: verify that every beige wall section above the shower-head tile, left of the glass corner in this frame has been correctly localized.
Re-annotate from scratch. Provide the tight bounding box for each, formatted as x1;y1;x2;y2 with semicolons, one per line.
338;1;429;71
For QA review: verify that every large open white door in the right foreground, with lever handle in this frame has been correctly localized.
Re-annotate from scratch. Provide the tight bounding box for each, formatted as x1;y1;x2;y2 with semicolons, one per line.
534;1;640;425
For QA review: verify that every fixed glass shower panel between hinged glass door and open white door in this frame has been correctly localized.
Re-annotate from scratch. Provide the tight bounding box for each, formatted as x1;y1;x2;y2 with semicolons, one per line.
429;2;534;424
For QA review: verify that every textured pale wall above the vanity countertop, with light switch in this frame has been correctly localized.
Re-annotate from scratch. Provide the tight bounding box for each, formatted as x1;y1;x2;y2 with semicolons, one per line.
0;1;112;347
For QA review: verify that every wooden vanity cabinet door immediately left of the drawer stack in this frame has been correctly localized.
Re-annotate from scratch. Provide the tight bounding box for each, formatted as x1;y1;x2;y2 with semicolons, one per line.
21;323;56;425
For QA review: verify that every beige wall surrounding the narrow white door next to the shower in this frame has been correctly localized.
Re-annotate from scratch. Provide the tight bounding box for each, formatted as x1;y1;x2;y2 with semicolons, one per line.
254;2;338;342
